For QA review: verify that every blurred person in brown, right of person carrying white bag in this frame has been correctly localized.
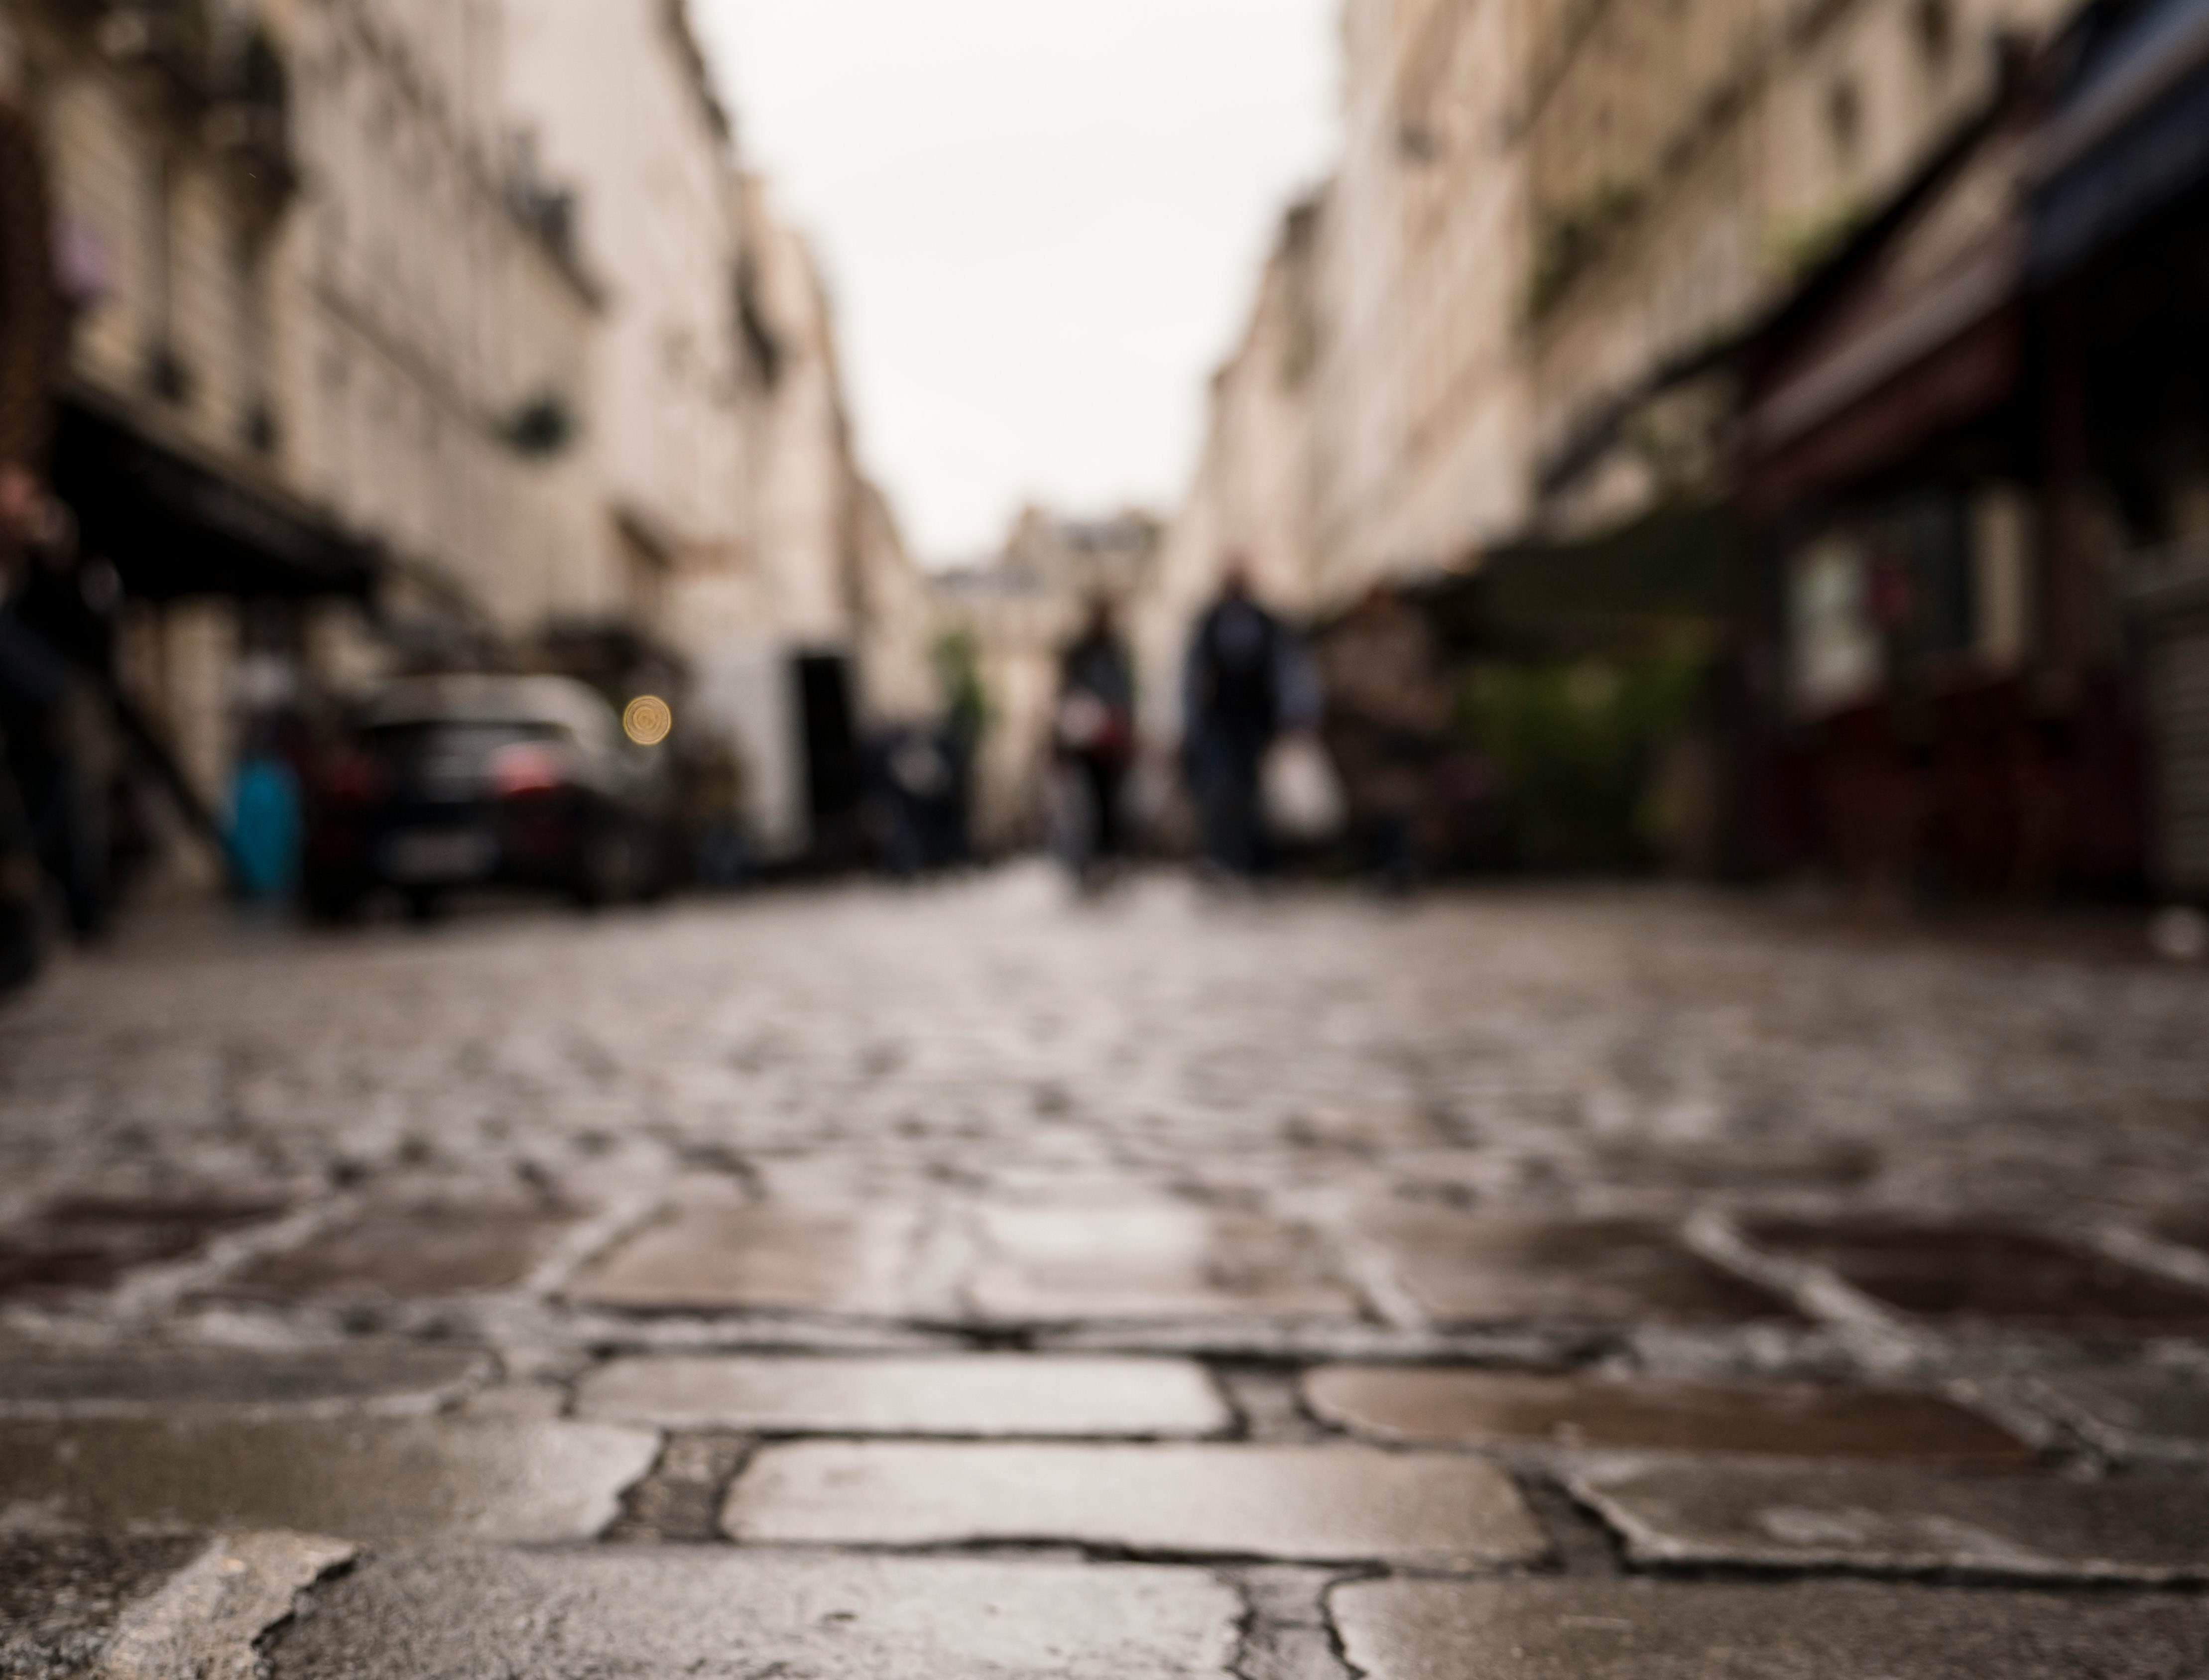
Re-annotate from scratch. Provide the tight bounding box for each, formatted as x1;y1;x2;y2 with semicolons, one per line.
1319;583;1449;892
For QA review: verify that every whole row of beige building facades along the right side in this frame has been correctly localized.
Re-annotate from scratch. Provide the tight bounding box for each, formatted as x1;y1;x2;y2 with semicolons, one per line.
1142;0;2072;728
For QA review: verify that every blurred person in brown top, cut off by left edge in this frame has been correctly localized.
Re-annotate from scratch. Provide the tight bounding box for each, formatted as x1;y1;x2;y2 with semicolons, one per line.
0;78;66;989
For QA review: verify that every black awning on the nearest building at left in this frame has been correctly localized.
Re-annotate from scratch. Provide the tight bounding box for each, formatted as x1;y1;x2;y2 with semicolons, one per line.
53;393;378;600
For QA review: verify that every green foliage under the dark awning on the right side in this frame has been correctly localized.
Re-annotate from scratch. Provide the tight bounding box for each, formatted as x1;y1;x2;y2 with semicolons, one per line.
1451;638;1710;867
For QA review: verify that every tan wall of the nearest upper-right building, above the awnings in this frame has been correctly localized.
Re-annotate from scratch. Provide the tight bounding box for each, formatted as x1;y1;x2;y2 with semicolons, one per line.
1524;0;2072;530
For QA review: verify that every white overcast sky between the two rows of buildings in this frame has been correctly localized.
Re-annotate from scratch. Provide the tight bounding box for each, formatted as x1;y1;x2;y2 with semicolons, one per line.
694;0;1339;563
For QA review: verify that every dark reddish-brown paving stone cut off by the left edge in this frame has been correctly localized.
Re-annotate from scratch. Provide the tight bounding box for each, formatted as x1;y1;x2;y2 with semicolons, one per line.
0;1190;283;1300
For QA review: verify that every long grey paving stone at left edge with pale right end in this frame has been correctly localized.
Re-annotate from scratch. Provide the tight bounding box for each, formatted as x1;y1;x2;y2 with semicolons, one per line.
0;1415;658;1541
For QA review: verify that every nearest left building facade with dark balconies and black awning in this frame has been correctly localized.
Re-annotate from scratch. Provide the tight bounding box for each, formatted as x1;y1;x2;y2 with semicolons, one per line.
23;0;371;852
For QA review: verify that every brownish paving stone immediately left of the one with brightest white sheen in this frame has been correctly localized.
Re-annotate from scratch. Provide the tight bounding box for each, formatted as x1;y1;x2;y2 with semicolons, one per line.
568;1203;917;1316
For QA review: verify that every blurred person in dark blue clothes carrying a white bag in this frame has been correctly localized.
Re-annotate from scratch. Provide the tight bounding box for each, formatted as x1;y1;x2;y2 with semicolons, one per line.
1182;559;1317;881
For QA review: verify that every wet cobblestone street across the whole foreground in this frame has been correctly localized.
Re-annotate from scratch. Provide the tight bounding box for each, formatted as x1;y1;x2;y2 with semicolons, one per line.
0;870;2209;1680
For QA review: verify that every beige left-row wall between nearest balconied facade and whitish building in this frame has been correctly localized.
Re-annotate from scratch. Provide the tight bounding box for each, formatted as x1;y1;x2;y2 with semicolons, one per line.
280;0;612;638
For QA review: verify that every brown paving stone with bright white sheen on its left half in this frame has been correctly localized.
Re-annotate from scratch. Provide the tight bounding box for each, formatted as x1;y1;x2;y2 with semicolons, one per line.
970;1201;1358;1320
